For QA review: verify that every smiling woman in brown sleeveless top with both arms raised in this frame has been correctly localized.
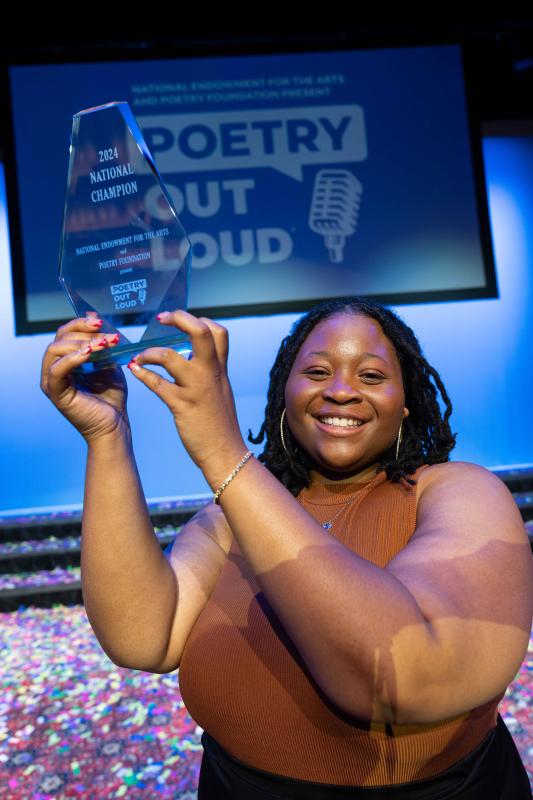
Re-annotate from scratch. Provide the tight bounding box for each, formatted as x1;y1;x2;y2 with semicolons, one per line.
42;298;533;800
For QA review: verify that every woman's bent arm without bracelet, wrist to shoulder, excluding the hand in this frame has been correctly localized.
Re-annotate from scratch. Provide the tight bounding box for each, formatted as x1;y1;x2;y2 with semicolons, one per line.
81;435;231;673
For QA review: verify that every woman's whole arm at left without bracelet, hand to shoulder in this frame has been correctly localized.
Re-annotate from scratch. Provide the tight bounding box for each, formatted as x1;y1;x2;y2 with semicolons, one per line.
41;319;230;672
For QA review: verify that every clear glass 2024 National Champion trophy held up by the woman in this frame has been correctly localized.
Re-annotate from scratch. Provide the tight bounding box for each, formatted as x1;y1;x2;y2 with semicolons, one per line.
59;103;191;372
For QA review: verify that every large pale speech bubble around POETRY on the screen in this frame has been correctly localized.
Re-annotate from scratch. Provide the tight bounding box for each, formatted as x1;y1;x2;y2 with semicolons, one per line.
129;104;367;181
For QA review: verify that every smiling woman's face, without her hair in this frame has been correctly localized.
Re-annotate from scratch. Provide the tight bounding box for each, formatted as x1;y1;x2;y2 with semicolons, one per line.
285;312;409;480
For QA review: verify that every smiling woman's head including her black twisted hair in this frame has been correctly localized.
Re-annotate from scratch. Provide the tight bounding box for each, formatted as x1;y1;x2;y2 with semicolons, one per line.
249;298;455;496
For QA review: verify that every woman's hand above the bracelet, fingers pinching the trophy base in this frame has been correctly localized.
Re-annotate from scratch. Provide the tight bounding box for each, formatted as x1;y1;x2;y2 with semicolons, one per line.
128;310;247;480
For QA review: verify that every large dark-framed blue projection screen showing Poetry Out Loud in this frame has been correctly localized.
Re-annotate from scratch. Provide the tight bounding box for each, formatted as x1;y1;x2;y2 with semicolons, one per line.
5;45;496;334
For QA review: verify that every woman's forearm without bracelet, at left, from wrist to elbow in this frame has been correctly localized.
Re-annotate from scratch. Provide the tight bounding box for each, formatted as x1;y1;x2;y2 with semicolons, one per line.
81;432;177;671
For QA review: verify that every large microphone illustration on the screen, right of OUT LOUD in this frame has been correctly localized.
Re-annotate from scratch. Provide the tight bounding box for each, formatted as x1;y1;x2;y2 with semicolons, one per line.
309;169;363;264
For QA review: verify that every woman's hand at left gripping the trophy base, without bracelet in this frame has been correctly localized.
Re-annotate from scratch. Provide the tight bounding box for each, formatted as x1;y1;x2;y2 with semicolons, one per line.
41;316;129;443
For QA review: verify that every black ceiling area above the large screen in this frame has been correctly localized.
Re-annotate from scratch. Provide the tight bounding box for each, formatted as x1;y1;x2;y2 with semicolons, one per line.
1;18;533;121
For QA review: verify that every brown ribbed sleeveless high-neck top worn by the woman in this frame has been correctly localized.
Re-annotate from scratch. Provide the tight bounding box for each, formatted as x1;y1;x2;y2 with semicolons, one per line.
179;467;503;786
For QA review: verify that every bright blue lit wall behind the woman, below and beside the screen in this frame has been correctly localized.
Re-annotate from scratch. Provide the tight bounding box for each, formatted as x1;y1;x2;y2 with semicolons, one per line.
0;138;533;512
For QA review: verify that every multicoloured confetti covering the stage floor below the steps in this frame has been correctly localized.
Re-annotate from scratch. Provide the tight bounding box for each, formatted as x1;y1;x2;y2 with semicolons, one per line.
0;605;533;800
